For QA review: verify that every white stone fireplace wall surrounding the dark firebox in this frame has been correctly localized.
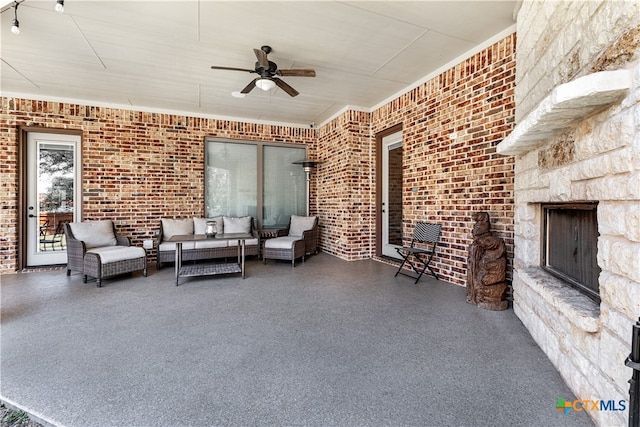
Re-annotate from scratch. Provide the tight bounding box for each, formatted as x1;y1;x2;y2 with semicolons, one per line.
513;1;640;425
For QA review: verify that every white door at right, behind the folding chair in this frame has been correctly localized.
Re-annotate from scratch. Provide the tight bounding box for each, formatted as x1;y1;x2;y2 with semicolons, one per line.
382;131;403;259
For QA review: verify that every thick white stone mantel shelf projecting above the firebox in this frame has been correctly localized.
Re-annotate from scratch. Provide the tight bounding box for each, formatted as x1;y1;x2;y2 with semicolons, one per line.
496;70;631;155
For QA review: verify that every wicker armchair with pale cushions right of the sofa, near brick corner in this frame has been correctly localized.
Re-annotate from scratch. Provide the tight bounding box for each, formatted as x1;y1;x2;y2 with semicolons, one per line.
262;215;318;267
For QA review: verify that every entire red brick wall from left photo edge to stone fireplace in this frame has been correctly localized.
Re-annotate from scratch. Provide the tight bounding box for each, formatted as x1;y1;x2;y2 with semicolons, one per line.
0;34;515;285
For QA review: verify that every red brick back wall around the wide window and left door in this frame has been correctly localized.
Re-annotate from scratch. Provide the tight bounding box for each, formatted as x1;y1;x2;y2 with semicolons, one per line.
0;98;316;272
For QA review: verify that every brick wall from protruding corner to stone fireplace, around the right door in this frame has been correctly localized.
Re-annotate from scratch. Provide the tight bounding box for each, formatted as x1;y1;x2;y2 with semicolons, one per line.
314;34;516;285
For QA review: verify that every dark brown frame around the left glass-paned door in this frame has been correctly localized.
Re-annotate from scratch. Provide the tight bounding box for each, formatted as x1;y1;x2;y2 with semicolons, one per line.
16;126;84;270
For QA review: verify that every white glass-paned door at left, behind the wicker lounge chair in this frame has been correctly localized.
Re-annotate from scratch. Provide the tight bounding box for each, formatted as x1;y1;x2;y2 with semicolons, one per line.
26;132;81;267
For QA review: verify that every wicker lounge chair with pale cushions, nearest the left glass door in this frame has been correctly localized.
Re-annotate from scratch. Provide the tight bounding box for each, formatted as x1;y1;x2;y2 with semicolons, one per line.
65;220;147;287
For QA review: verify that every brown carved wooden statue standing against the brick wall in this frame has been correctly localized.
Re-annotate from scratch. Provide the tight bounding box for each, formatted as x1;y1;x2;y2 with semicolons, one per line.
467;212;509;311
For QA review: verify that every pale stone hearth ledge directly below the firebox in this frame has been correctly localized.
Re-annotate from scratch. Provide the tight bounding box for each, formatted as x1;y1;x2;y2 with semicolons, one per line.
517;267;601;333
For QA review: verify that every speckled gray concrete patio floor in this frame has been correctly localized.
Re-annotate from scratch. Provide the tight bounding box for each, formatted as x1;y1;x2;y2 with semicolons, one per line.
0;254;593;426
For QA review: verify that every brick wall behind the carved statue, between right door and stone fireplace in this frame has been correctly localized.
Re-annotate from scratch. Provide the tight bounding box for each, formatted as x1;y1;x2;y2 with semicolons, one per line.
371;34;516;285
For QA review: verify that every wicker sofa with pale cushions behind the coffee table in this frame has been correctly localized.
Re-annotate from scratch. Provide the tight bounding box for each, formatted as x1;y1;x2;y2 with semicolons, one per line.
156;216;260;269
